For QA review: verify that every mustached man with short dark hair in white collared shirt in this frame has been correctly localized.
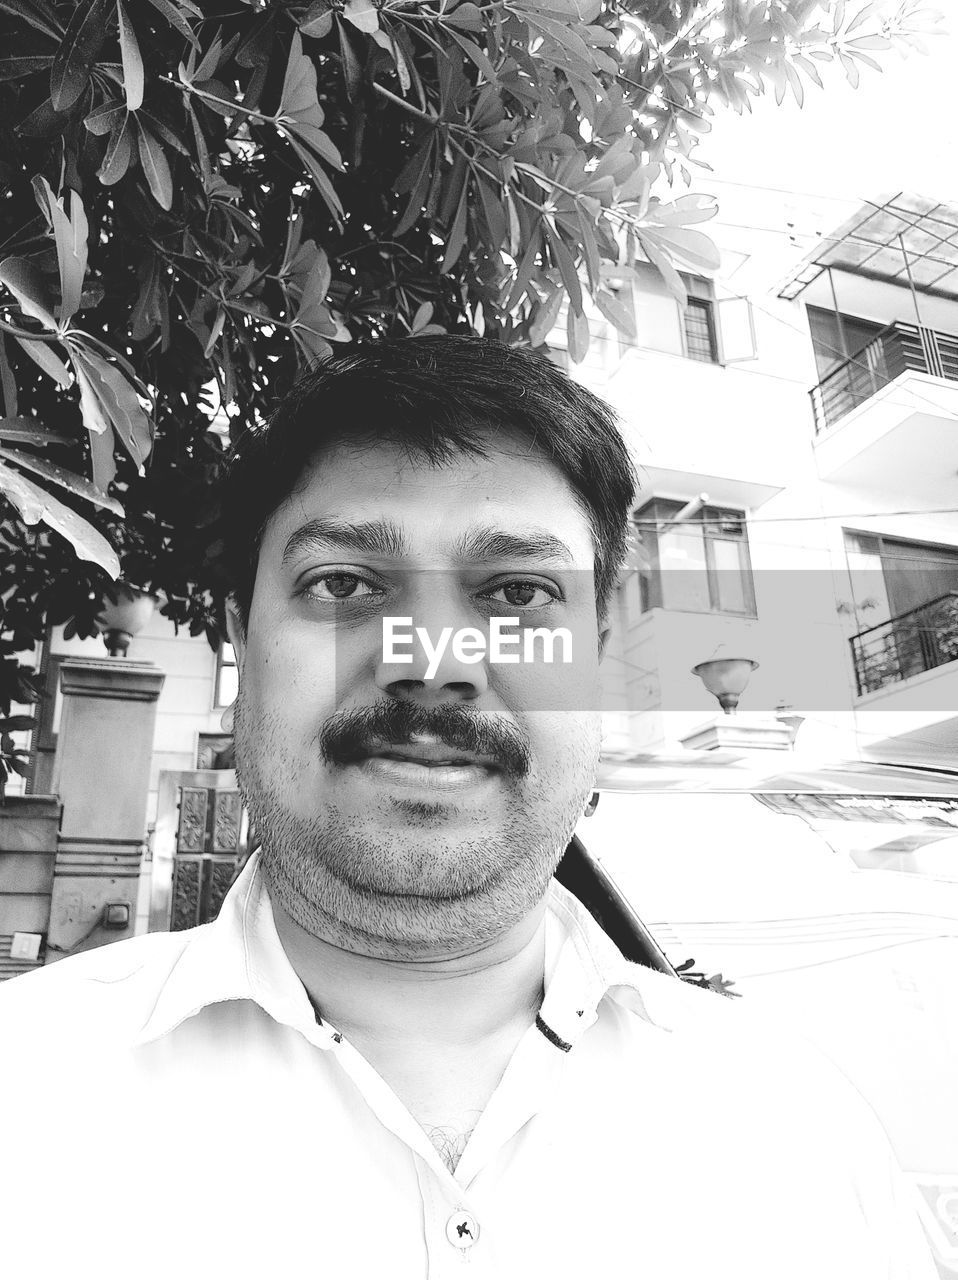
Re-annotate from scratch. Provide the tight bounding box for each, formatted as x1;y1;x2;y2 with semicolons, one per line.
0;338;934;1280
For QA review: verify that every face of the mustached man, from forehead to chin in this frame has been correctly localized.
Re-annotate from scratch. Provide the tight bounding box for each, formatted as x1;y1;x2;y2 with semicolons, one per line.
231;434;601;956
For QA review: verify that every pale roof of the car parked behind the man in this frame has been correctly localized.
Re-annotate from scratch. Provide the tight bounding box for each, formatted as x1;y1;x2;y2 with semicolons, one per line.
596;750;958;796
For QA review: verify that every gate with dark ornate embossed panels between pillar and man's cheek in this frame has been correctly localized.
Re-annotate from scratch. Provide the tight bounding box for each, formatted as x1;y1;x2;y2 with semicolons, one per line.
150;769;248;933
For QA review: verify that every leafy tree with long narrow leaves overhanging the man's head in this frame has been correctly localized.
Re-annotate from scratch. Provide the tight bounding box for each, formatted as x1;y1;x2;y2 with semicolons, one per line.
0;0;935;783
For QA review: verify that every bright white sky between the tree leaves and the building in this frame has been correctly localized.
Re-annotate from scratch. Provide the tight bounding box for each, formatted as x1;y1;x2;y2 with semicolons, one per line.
675;18;958;282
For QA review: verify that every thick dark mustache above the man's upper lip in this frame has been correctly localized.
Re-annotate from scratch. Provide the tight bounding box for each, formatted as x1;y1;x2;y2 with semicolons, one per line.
319;701;533;778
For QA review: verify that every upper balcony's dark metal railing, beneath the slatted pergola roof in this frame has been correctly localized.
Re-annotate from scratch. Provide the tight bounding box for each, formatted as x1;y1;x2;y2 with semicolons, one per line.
809;320;958;434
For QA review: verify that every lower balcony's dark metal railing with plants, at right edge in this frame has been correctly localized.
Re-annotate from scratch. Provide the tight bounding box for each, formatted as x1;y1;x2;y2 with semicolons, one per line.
850;591;958;696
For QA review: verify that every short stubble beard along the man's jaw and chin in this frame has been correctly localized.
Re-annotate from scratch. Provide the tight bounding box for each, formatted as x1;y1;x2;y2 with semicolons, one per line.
234;694;594;959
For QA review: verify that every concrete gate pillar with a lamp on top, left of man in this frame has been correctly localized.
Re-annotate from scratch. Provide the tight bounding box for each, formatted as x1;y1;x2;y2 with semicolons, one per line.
46;658;165;963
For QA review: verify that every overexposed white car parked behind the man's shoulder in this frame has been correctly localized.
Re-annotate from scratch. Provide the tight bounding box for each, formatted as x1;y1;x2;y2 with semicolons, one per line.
566;750;958;1280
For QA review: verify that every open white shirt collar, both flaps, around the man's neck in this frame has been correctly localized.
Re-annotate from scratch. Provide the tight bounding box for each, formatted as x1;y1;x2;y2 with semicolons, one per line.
136;852;676;1048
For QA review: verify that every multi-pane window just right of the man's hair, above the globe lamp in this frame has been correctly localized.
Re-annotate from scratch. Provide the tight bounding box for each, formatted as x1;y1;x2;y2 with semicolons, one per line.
635;498;756;617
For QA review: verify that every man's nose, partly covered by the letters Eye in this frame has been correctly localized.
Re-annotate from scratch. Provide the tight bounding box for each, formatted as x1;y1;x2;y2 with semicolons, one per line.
375;600;489;701
